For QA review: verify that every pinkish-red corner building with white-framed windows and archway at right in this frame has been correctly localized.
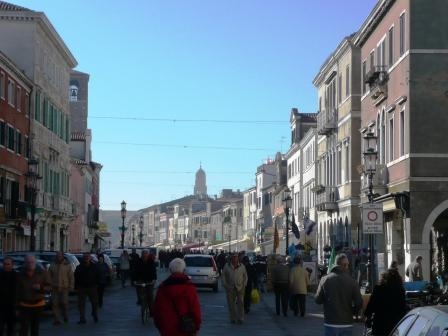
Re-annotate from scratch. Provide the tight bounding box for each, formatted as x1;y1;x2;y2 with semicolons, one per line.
355;0;448;280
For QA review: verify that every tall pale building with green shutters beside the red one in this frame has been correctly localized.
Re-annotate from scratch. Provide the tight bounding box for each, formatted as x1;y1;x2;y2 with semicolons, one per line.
0;2;77;250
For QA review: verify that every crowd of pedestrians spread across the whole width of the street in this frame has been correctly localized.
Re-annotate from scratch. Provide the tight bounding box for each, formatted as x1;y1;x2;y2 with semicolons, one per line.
0;244;430;336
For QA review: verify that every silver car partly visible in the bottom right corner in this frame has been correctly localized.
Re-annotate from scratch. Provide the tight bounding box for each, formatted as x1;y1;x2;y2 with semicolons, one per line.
390;305;448;336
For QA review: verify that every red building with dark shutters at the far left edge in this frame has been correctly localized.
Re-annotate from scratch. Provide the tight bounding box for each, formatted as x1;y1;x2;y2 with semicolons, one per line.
0;52;33;252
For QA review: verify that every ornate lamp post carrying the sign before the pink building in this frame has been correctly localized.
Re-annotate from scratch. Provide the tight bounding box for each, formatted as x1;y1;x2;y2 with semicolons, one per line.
363;131;378;290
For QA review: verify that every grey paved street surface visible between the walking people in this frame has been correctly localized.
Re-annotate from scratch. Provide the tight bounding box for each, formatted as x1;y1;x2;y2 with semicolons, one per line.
41;273;362;336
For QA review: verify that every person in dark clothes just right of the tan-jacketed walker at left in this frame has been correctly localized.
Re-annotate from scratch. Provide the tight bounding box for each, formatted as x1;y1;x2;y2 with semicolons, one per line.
75;252;100;324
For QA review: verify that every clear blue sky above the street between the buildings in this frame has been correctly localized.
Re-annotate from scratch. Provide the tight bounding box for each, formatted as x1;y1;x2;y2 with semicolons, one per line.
13;0;377;210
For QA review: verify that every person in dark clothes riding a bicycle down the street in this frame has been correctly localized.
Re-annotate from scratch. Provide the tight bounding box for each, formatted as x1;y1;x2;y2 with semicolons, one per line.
135;250;157;316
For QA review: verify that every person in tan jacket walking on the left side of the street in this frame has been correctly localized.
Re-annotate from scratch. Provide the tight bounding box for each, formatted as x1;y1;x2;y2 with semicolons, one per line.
48;251;75;325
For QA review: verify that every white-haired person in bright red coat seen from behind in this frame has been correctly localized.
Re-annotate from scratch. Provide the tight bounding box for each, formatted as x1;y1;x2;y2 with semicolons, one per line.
154;258;202;336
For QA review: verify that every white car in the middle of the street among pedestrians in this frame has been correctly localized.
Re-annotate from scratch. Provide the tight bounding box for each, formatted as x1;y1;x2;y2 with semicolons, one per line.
184;254;219;292
